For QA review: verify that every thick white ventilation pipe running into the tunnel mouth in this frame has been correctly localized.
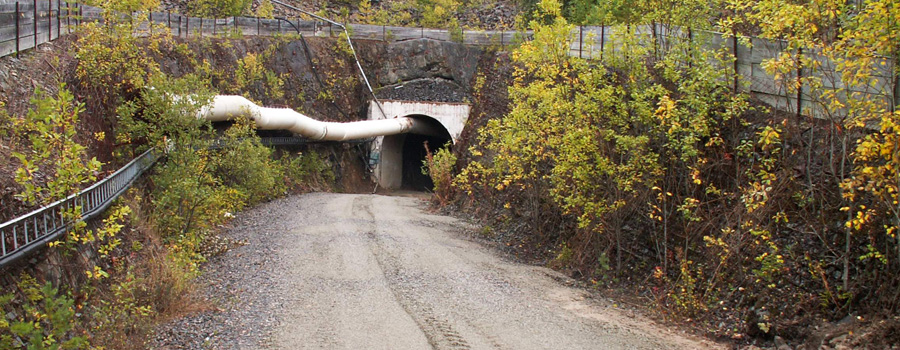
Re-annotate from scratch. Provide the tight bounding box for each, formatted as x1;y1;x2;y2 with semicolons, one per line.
197;95;441;141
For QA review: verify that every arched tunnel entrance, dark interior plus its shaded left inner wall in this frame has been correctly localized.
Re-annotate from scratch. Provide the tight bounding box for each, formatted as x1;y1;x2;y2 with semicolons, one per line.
379;115;452;191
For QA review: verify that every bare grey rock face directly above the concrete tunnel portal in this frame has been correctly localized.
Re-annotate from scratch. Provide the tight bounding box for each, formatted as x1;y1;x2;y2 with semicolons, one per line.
375;39;482;93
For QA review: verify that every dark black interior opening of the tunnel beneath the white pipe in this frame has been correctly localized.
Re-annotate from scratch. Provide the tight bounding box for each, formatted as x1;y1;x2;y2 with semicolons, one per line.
401;116;451;191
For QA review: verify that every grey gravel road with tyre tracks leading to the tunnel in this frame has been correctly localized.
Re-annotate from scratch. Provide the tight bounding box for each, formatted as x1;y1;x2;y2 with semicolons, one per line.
150;193;716;349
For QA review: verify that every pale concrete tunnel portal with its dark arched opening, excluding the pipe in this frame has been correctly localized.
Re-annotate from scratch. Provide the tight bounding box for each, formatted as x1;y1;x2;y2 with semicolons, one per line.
369;100;469;191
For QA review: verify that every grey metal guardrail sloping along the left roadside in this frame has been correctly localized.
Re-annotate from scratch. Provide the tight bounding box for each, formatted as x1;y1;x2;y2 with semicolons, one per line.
0;149;160;267
